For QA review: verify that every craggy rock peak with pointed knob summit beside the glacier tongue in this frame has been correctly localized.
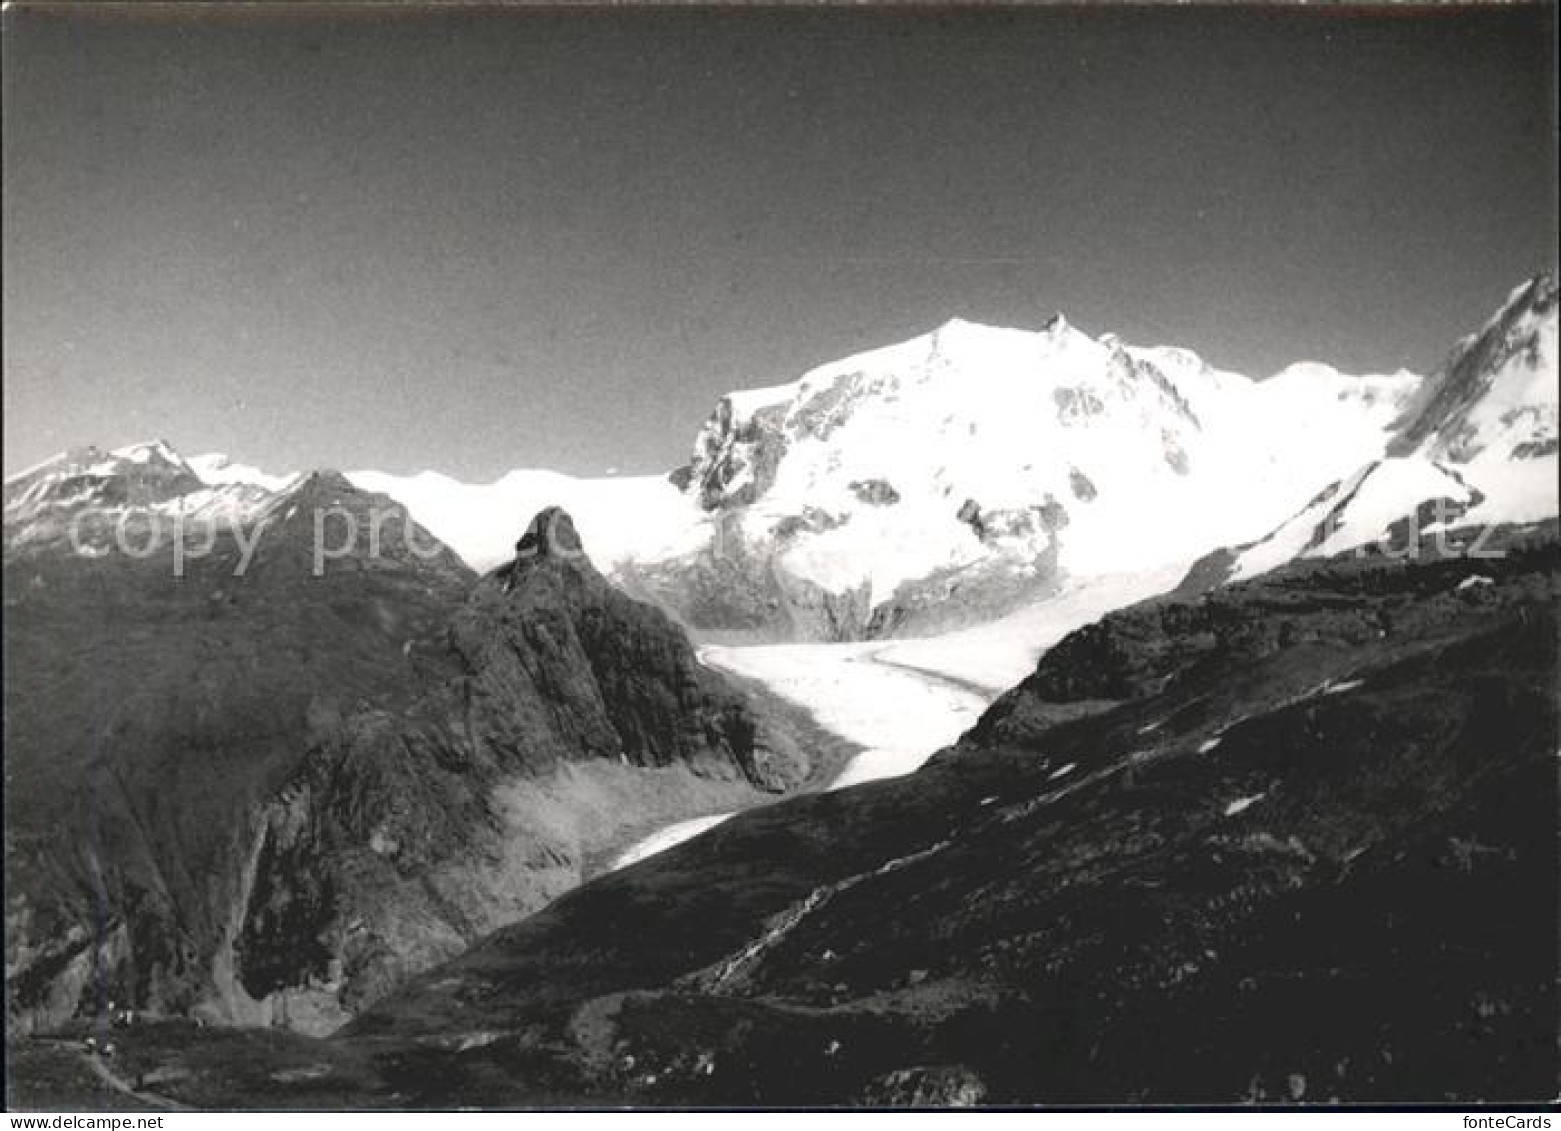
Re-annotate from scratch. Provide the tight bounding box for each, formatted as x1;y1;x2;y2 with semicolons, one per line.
239;509;807;1019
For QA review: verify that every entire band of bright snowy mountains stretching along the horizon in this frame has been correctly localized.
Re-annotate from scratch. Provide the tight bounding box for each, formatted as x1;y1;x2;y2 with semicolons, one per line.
6;269;1558;640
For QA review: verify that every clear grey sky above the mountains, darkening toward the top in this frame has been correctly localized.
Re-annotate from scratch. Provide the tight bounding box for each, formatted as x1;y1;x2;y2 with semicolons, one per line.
0;5;1556;480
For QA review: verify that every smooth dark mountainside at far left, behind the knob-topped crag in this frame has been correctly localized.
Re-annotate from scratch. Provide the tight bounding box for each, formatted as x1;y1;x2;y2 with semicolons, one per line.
5;471;471;1026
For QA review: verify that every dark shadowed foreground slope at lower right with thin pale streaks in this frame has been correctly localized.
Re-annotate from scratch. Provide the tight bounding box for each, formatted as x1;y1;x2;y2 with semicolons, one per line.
310;523;1561;1104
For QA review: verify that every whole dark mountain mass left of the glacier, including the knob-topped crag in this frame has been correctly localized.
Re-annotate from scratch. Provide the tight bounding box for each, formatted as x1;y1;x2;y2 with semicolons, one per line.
5;457;807;1031
